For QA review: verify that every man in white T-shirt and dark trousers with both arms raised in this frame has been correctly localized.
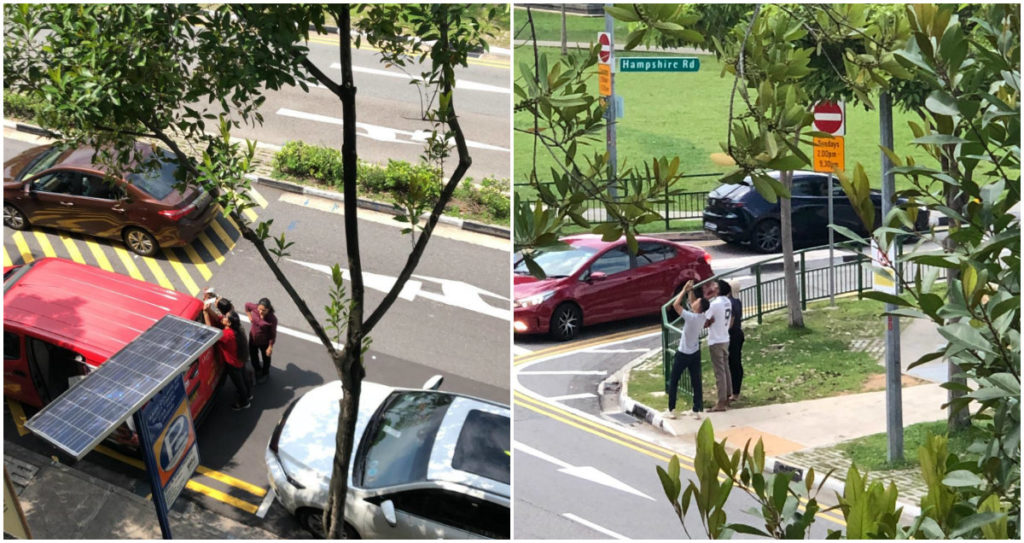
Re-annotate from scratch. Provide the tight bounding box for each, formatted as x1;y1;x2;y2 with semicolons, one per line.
665;280;710;420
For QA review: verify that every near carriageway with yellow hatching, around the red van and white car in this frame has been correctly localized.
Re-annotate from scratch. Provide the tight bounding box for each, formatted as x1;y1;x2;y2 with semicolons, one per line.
3;131;510;537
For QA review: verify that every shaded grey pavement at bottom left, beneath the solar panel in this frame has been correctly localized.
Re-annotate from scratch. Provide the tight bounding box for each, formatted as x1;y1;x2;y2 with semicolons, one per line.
3;442;279;540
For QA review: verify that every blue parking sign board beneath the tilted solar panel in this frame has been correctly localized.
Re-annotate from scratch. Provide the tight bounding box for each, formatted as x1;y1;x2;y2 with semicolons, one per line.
135;377;199;539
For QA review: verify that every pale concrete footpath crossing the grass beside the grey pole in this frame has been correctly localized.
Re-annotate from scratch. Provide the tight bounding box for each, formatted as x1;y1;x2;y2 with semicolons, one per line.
624;319;947;511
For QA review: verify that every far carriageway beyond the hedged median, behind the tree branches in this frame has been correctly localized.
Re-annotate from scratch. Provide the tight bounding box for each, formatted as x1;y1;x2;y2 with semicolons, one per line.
232;36;512;181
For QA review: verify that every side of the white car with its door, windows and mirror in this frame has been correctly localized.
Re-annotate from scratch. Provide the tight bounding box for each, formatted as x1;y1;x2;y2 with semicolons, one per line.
355;488;511;539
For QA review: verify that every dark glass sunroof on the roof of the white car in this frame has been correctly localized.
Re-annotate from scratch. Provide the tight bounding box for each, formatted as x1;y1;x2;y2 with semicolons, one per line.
452;410;511;485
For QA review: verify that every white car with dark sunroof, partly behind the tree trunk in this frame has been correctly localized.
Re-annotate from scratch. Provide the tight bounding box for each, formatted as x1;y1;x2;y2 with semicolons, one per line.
266;377;511;539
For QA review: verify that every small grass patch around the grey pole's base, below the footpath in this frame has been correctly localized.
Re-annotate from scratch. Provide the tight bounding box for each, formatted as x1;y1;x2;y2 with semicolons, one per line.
835;420;973;471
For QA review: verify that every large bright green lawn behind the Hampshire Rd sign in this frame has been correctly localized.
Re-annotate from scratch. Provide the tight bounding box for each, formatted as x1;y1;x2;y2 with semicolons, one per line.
512;44;931;198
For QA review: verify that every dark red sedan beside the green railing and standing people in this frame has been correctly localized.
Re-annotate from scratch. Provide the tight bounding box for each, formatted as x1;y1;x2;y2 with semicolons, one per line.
513;235;713;340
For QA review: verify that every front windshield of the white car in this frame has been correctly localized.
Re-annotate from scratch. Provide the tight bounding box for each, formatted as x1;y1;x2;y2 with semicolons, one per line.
362;390;455;489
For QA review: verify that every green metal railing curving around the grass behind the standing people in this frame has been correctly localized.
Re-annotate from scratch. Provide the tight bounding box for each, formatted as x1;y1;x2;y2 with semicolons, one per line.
662;243;944;394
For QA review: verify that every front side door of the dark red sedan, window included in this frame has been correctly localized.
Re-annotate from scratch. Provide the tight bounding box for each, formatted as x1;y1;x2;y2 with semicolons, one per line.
573;244;638;324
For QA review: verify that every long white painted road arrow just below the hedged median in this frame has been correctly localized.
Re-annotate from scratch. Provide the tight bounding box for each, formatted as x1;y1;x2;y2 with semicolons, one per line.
287;258;512;321
